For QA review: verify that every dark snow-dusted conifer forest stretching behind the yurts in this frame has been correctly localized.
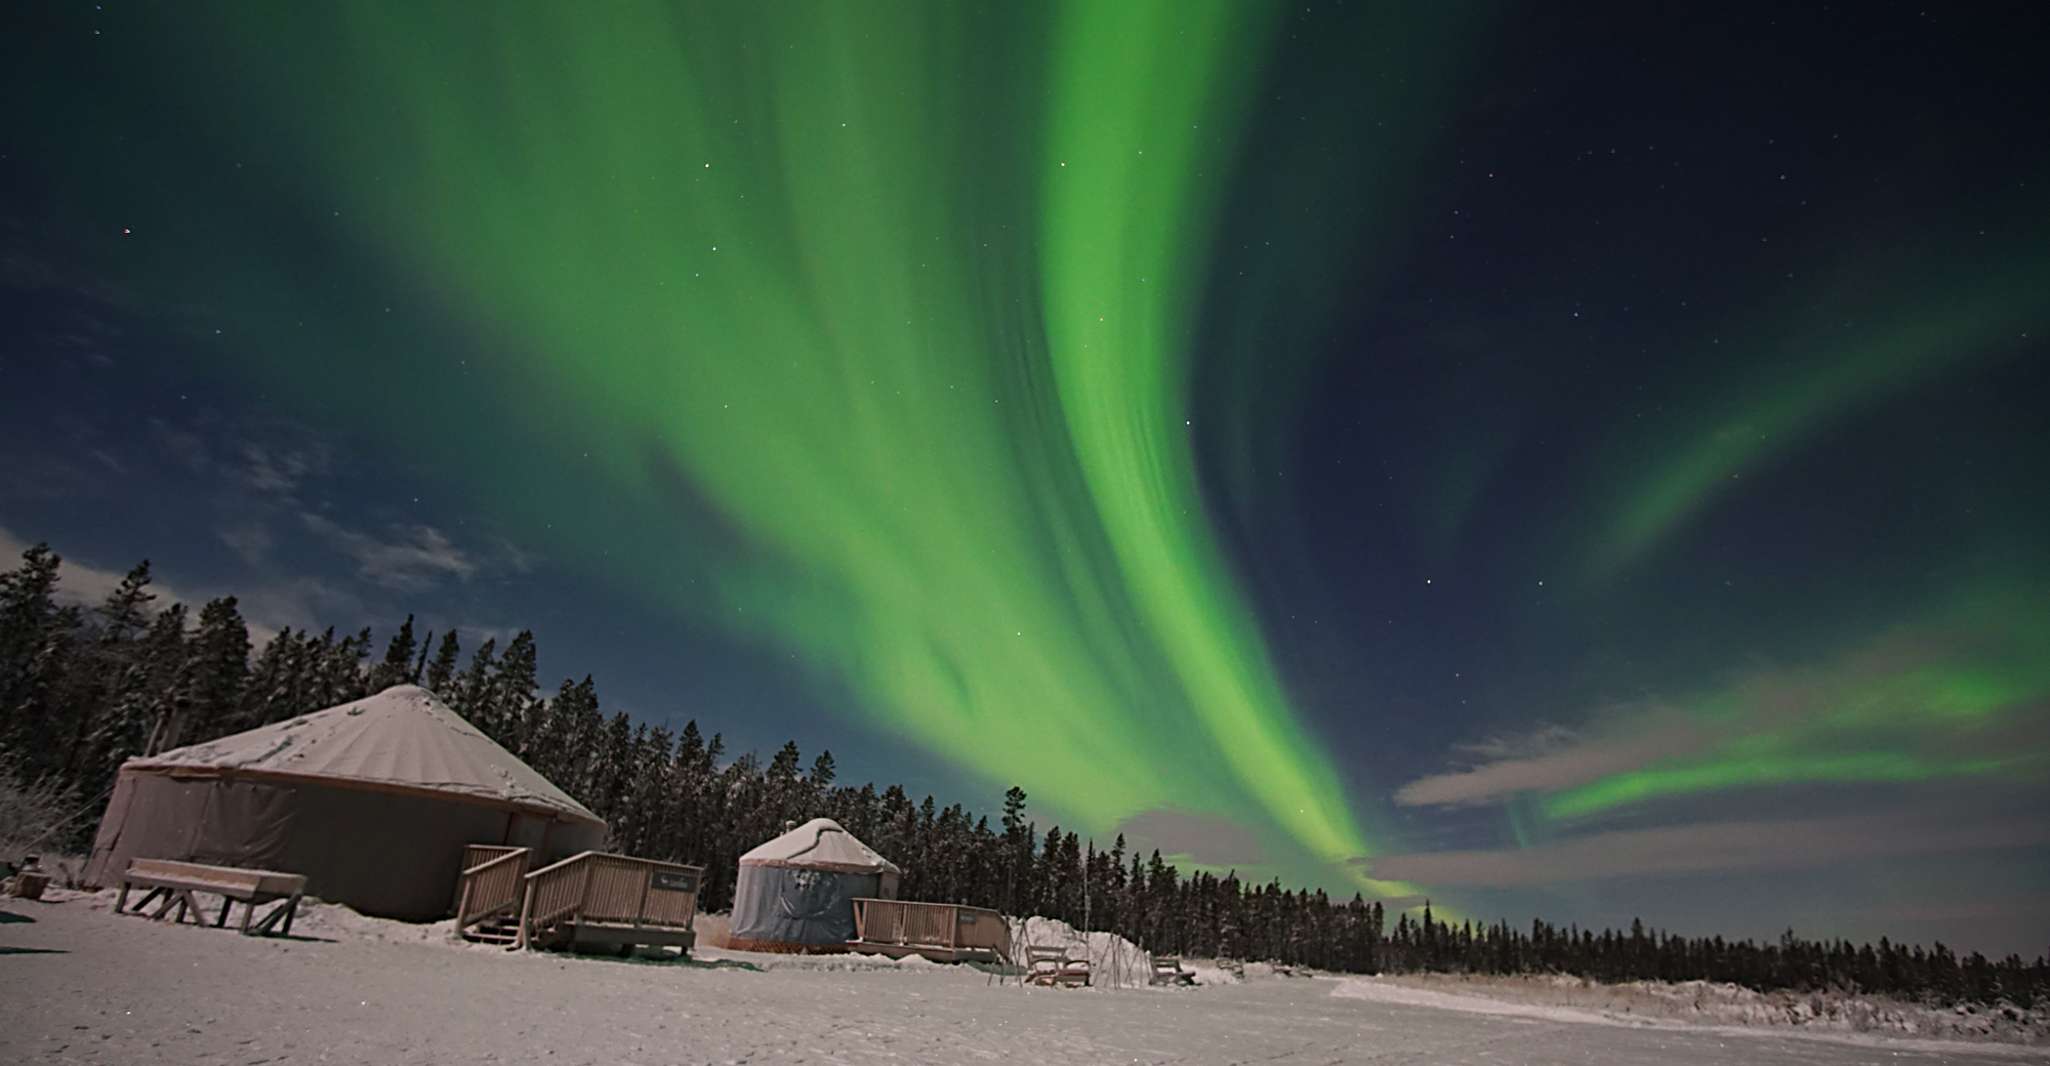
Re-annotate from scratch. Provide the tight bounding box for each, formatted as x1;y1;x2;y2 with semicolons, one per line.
0;545;2050;1007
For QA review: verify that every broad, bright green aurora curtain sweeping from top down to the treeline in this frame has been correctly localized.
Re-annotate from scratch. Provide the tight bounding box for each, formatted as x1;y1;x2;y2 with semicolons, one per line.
48;2;1410;894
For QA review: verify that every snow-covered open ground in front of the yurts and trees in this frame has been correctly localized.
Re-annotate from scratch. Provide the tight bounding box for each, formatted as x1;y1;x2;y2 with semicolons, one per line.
0;894;2044;1066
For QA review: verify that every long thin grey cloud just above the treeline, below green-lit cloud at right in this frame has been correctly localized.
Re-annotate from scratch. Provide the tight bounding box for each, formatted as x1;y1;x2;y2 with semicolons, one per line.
1353;812;2050;888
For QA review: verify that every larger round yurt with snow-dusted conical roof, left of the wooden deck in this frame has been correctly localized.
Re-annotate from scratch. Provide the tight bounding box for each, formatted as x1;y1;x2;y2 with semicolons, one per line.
86;685;605;920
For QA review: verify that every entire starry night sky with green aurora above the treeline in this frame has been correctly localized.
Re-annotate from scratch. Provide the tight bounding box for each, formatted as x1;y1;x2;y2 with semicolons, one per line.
0;0;2050;955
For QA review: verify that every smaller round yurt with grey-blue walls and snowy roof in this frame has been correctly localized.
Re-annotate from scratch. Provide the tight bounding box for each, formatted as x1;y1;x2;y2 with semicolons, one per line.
728;818;904;951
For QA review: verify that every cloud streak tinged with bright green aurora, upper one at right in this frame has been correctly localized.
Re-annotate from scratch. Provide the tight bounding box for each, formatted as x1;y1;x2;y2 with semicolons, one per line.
1394;590;2050;818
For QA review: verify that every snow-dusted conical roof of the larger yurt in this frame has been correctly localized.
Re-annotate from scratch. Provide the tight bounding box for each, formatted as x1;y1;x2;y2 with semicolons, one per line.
123;685;603;824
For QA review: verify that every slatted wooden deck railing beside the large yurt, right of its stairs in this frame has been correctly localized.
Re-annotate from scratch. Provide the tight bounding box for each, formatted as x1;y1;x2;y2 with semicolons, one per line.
519;851;705;947
